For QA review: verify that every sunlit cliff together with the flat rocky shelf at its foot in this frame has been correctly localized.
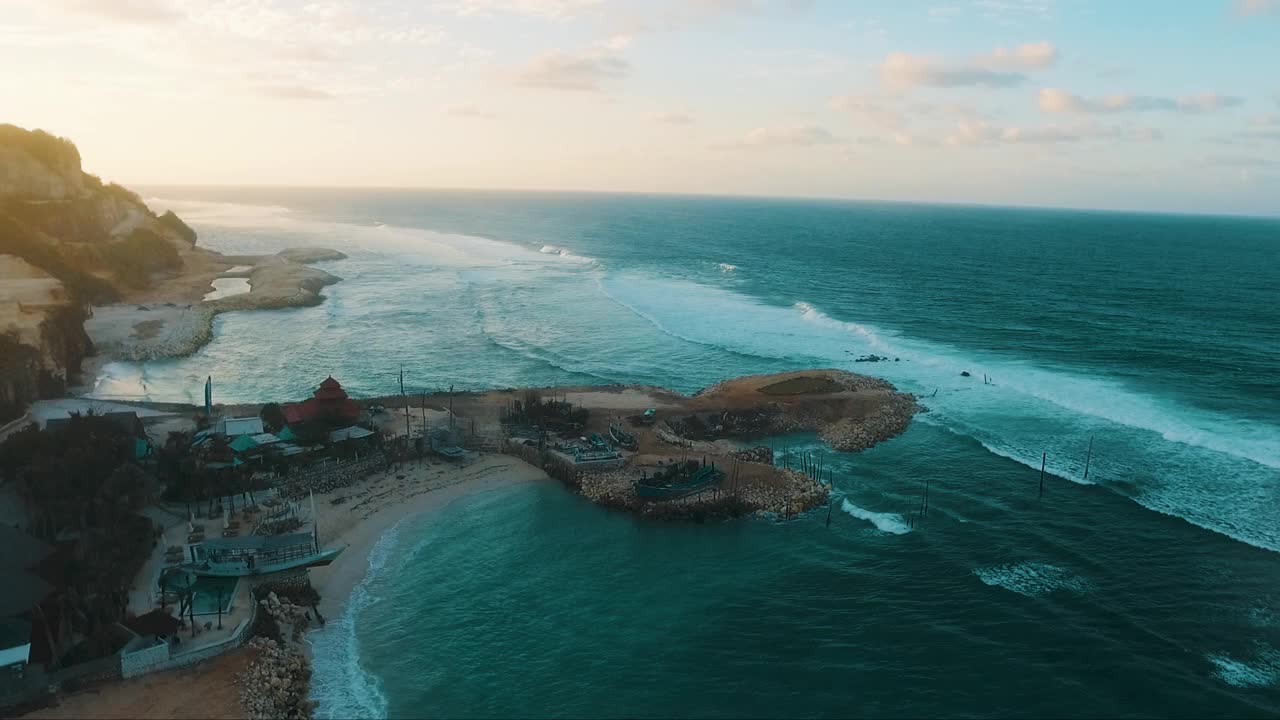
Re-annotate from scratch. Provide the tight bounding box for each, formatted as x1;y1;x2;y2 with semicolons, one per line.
0;124;343;404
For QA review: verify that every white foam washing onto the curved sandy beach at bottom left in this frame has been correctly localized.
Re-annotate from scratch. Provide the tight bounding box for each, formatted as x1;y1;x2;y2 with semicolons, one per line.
306;520;403;720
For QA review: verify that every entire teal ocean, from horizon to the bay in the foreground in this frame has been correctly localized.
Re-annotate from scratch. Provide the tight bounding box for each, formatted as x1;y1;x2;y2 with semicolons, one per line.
112;188;1280;717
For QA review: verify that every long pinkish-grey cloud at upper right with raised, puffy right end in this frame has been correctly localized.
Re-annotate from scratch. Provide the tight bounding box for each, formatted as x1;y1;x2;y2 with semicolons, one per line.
879;41;1057;90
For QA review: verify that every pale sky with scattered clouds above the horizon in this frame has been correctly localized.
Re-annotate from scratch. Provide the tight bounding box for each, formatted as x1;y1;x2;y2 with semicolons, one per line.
0;0;1280;215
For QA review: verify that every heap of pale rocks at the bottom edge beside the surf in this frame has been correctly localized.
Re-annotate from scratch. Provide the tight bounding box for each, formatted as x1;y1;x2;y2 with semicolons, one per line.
239;637;316;720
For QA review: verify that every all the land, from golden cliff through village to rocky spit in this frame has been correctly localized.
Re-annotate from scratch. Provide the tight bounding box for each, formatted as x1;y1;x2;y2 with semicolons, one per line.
0;126;923;717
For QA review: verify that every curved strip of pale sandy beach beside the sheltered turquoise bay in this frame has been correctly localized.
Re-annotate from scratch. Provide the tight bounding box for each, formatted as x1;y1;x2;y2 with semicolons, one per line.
311;455;554;619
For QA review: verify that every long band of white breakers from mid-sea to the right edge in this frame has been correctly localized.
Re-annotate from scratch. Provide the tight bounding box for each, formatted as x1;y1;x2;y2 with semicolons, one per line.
600;274;1280;551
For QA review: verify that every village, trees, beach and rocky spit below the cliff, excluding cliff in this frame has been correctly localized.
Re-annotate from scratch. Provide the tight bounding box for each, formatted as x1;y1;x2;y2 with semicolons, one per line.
0;370;918;717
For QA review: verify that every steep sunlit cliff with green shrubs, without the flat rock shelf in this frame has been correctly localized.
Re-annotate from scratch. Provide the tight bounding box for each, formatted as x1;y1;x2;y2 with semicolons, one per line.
0;126;202;423
